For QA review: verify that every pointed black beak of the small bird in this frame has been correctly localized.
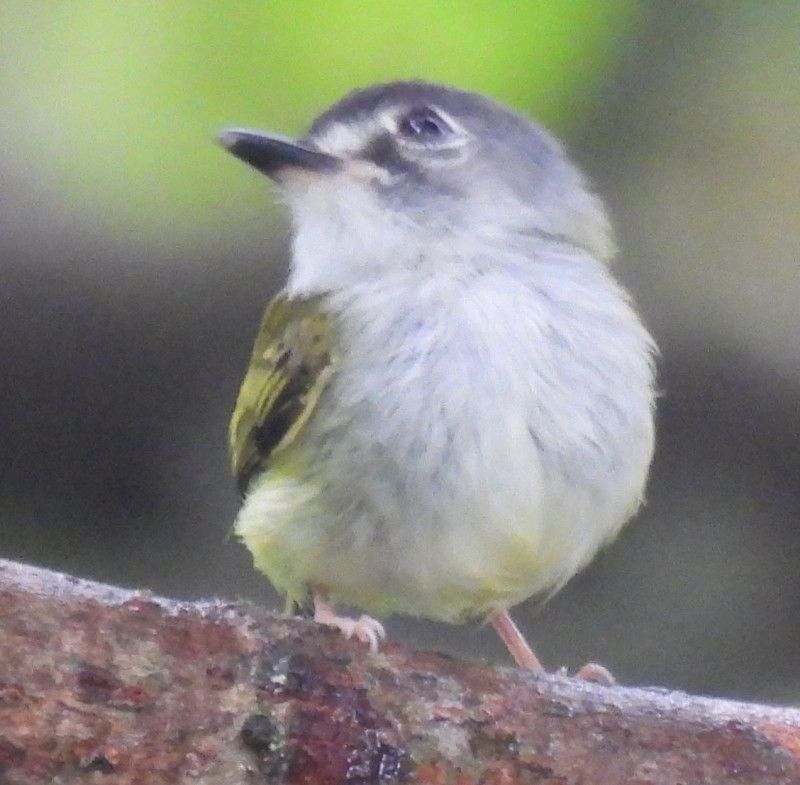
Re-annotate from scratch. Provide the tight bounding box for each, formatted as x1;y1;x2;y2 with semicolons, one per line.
217;128;341;179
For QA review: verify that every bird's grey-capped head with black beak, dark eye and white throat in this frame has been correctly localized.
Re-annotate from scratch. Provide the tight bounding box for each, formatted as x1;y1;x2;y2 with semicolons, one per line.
219;82;613;288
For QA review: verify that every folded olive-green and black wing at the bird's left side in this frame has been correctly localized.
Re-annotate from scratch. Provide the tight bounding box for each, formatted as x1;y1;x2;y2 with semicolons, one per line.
229;294;335;491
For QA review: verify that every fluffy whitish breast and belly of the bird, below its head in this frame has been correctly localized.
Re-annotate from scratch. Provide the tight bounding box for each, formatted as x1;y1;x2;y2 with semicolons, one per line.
268;251;653;620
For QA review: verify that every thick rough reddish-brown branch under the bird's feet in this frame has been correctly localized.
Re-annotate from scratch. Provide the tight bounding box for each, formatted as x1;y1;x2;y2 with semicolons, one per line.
0;561;800;785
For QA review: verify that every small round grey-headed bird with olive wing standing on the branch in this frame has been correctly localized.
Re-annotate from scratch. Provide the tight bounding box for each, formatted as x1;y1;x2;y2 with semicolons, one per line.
219;81;655;679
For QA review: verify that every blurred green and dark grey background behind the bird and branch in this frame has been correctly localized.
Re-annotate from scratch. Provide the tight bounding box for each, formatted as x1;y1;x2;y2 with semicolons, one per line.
0;0;800;703
